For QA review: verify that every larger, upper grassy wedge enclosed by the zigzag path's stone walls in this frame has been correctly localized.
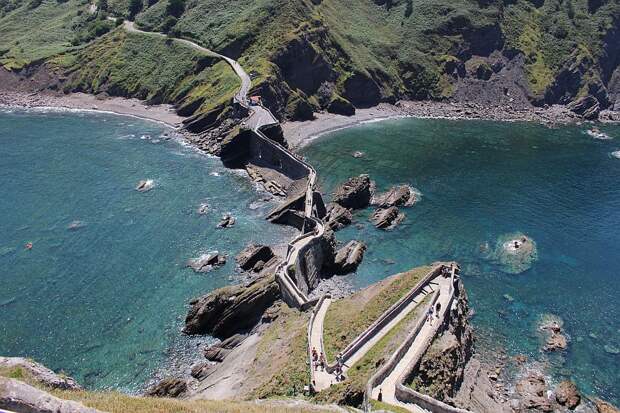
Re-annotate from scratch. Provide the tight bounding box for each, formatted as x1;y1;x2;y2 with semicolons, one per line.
323;267;431;360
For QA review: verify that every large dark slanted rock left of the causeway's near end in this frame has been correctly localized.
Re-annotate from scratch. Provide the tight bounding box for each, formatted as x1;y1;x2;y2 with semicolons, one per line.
183;274;280;338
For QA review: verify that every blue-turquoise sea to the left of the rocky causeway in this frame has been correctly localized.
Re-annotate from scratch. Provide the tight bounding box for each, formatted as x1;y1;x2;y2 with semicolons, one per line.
0;110;290;391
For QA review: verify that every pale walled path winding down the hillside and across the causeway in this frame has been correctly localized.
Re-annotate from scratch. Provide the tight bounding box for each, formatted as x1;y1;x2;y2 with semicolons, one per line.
123;21;325;309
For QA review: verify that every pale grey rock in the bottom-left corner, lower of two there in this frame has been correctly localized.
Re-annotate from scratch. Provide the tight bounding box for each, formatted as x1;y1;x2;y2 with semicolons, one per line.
0;377;102;413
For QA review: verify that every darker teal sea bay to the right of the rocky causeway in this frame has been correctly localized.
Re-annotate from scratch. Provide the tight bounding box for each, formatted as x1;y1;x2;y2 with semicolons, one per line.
304;119;620;403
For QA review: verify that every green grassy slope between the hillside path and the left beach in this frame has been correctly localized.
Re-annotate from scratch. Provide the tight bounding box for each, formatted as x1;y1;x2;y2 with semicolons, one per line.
45;28;239;110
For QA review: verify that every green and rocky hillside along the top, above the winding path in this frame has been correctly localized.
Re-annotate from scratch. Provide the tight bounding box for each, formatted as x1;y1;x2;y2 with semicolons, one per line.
0;0;620;122
